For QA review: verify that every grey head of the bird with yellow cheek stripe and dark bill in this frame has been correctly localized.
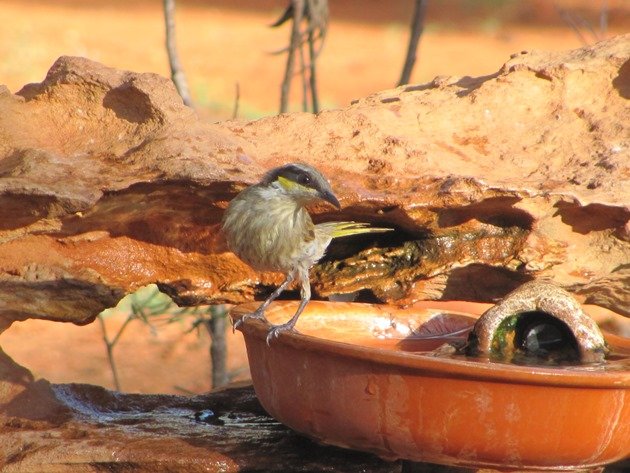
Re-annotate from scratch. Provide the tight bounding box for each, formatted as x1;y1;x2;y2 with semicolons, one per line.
260;163;341;209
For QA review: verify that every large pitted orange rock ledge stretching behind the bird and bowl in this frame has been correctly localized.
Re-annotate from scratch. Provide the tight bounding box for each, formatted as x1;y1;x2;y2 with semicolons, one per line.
0;35;630;336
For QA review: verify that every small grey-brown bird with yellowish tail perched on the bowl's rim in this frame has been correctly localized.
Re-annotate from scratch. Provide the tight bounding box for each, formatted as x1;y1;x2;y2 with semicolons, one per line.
222;163;393;345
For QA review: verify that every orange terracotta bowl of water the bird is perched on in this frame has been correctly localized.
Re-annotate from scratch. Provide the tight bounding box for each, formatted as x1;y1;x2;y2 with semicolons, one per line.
231;301;630;470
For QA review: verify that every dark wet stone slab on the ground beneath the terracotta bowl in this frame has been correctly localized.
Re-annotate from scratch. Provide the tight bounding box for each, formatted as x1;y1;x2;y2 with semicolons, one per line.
0;384;401;473
